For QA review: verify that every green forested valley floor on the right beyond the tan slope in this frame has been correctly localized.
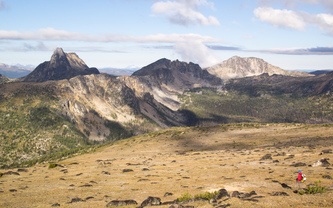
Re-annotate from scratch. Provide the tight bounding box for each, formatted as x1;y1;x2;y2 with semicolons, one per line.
180;88;333;123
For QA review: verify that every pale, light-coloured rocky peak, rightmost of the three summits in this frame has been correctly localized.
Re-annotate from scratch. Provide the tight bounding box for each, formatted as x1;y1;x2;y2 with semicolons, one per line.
207;56;312;80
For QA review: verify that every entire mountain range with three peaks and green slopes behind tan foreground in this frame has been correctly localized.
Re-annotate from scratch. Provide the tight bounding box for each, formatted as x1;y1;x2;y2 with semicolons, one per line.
0;48;333;165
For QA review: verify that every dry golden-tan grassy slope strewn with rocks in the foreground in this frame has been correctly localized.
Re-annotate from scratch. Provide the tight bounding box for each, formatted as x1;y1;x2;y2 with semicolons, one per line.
0;124;333;208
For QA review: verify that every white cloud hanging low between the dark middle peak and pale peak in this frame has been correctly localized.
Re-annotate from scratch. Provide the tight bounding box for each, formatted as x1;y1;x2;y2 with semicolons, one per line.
175;41;221;67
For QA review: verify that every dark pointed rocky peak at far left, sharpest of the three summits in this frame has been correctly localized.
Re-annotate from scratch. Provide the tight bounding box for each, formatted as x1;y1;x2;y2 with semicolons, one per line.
23;48;99;82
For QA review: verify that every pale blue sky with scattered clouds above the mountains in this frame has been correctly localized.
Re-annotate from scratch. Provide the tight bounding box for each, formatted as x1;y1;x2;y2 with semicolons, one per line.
0;0;333;70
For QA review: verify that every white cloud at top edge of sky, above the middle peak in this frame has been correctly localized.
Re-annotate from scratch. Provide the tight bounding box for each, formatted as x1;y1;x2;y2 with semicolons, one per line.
151;0;220;26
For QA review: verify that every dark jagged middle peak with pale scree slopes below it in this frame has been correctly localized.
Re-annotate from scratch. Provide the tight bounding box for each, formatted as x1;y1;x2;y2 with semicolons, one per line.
127;59;223;110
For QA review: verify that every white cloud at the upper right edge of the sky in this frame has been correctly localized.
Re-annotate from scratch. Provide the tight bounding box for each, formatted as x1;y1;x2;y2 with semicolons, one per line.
254;7;333;35
